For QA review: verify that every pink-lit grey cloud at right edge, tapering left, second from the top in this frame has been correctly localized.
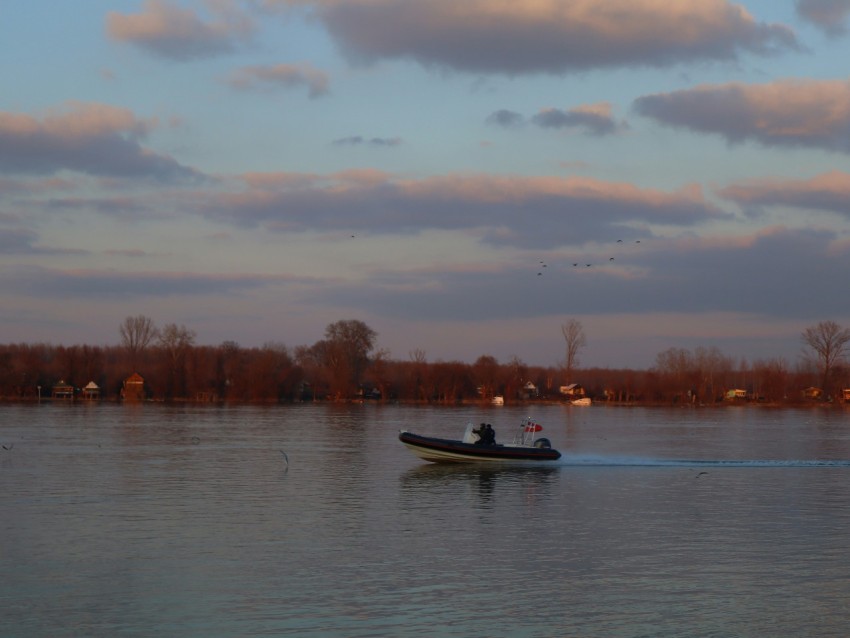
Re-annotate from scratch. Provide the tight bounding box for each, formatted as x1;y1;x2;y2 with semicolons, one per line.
633;79;850;153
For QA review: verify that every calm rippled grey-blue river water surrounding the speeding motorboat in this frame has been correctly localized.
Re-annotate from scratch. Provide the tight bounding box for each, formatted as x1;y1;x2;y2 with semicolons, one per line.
0;404;850;638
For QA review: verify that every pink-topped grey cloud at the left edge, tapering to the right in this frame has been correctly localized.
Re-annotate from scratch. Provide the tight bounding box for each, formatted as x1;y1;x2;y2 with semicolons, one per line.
0;103;199;180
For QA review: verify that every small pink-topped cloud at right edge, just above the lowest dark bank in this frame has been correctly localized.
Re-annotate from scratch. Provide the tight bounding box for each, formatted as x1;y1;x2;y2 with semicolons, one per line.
718;171;850;219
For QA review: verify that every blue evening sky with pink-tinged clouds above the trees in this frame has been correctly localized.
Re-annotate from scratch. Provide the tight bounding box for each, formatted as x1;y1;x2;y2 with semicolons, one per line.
0;0;850;369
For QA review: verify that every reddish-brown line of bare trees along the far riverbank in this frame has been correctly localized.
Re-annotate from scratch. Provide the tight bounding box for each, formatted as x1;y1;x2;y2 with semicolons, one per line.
0;315;850;404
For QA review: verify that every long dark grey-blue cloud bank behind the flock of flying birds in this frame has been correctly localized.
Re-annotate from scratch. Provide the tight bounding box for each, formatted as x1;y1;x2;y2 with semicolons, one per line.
309;228;850;325
